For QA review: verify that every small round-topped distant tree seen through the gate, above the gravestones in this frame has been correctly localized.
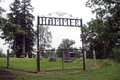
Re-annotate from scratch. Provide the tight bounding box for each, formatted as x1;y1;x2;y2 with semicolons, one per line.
57;39;75;57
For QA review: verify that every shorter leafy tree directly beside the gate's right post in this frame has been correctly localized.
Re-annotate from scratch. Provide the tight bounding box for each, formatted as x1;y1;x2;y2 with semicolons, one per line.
83;19;105;58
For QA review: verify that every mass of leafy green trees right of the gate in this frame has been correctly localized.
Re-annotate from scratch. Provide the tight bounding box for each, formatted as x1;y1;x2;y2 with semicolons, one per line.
81;0;120;62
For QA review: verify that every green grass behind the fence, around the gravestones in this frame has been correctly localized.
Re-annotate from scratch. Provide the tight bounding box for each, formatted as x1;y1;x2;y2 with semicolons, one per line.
0;58;101;71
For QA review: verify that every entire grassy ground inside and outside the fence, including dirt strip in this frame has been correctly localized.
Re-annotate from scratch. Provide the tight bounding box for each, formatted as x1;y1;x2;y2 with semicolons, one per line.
0;58;120;80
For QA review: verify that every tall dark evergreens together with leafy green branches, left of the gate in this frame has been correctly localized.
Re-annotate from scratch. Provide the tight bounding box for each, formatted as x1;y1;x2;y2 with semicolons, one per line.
1;0;35;57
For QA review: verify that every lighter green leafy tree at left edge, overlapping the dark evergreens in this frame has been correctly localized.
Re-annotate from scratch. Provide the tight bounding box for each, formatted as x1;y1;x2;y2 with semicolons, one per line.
0;7;24;53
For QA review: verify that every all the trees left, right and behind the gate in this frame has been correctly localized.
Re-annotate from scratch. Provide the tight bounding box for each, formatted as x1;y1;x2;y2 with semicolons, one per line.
0;0;120;62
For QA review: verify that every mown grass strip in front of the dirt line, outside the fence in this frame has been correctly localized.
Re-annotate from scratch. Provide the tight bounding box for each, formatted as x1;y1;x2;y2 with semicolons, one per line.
0;60;120;80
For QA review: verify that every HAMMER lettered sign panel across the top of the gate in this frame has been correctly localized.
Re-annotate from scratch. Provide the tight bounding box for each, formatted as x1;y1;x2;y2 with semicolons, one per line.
38;16;82;27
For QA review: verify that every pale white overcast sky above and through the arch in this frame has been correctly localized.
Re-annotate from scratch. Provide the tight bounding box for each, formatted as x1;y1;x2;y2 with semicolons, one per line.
0;0;95;53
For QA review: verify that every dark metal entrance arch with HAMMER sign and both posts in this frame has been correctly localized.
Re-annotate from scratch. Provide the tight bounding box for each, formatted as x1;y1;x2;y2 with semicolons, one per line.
37;13;85;72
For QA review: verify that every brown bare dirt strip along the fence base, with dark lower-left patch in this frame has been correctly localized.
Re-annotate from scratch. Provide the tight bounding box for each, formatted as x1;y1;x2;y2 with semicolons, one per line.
0;63;102;77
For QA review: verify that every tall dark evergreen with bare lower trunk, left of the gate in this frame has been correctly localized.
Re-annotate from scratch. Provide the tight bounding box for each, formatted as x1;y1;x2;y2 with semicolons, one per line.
8;0;35;57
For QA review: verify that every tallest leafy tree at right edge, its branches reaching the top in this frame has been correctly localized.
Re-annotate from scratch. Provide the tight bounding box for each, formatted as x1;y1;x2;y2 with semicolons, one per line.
86;0;120;57
